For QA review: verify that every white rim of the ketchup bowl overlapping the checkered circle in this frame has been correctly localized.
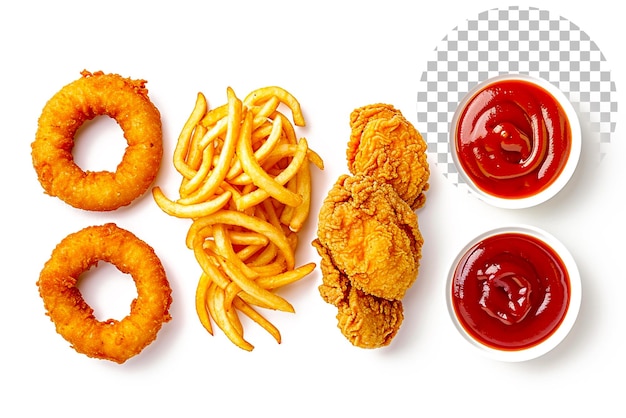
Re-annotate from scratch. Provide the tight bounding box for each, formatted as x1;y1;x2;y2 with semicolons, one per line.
449;74;582;209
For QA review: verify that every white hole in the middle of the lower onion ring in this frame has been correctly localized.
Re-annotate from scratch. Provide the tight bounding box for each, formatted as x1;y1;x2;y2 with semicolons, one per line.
77;261;137;321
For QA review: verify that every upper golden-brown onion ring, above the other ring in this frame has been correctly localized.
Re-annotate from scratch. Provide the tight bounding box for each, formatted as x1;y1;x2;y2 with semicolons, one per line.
32;71;163;211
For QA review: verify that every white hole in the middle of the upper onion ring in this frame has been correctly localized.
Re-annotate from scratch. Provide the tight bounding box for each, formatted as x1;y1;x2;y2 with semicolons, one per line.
72;115;128;172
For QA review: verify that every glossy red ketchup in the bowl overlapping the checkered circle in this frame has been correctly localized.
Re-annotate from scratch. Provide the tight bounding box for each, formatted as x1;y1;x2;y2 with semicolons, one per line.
455;79;572;199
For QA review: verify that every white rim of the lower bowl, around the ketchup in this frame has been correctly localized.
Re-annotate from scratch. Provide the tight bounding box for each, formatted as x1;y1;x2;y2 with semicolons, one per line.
446;225;582;362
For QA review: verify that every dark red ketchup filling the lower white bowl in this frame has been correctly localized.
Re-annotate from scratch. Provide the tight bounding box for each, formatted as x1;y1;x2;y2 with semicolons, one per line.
451;232;570;350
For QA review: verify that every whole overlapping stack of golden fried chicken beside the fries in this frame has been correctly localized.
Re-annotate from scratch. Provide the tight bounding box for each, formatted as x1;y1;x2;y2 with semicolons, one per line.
313;104;430;348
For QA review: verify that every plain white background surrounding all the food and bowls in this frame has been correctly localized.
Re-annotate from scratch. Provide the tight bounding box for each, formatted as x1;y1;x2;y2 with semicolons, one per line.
0;0;626;417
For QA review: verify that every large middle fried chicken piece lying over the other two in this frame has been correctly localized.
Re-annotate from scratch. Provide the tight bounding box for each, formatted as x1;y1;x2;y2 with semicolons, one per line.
317;175;423;300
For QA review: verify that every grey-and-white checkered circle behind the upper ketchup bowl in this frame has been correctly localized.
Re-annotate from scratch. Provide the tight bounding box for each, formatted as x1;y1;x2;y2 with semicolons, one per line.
417;6;617;188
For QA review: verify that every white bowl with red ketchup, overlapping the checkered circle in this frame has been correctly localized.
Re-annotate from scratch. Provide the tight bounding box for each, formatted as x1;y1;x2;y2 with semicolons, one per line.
450;74;582;209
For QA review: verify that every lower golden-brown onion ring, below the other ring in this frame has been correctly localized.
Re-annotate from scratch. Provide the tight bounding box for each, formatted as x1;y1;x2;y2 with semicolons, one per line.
37;223;172;364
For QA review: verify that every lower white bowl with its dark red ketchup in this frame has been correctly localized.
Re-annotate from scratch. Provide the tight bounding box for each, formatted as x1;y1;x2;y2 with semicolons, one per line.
446;226;582;361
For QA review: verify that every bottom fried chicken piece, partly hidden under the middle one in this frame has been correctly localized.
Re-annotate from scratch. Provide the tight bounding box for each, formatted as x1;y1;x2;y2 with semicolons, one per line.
313;240;404;348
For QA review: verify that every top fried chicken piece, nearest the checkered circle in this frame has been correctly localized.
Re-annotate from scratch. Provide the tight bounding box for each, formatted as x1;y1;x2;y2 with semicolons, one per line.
346;103;430;210
